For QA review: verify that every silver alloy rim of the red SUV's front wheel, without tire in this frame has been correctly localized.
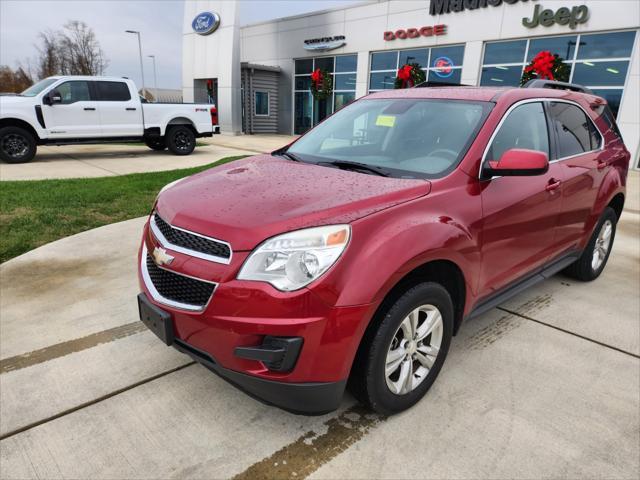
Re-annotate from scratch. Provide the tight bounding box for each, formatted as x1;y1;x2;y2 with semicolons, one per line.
385;305;443;395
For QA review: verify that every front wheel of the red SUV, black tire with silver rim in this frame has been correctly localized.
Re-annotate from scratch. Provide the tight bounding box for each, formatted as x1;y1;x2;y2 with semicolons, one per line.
349;282;454;415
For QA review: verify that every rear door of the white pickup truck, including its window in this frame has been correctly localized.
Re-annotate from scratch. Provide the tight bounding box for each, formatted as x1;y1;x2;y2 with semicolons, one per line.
93;80;143;137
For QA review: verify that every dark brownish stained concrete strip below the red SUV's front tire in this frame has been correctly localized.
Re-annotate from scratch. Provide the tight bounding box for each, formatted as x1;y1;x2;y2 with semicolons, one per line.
232;405;385;480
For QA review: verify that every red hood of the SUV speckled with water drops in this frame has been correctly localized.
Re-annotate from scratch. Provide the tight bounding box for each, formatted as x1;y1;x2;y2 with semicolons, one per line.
156;155;431;251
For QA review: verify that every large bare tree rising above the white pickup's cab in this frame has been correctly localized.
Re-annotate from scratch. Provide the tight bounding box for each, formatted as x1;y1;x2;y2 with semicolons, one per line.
60;20;107;75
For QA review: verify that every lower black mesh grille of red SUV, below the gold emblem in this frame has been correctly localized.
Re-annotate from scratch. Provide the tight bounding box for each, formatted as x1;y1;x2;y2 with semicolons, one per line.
145;253;216;310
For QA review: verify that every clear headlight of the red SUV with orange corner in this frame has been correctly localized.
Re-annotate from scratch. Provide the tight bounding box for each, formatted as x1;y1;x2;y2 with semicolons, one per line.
238;225;351;292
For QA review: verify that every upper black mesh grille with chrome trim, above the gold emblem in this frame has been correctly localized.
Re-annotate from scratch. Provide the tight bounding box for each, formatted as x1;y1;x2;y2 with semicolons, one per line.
153;212;231;263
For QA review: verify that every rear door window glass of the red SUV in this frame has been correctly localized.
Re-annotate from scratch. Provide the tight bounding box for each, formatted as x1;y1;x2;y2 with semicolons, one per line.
549;102;599;158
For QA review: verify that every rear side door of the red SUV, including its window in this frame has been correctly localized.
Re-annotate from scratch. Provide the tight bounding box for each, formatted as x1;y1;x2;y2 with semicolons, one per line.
548;101;611;249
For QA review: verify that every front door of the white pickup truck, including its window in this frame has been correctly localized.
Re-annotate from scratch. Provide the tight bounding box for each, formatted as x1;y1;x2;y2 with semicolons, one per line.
42;80;101;139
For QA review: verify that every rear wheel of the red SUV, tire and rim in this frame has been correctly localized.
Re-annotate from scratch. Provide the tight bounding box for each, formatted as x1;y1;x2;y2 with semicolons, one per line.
564;207;618;282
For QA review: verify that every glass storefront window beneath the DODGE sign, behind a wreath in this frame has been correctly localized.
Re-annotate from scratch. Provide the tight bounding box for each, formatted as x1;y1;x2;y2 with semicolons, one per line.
369;45;464;92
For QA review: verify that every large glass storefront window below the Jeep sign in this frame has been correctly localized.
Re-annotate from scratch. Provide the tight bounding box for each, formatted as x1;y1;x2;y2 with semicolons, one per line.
480;31;636;116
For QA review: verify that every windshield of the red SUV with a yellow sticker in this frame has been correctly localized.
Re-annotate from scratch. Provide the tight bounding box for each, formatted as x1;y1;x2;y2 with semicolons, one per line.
287;99;492;178
